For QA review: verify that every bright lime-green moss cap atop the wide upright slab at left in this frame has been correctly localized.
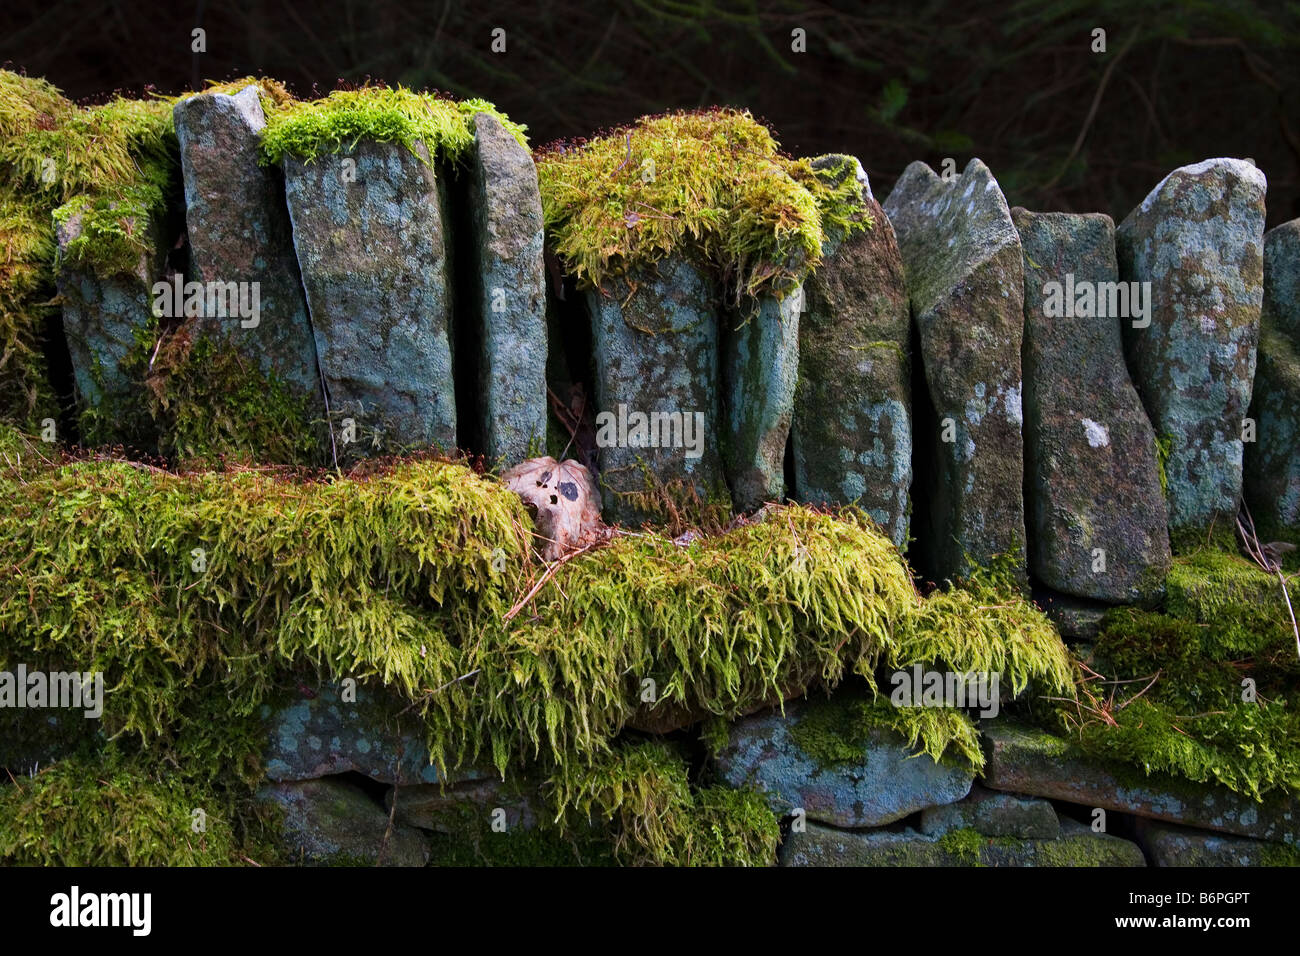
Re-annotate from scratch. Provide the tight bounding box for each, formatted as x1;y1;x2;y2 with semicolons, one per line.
261;87;528;164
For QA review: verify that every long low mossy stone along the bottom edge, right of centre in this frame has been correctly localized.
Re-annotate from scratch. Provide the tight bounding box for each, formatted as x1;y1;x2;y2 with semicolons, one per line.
779;821;1147;866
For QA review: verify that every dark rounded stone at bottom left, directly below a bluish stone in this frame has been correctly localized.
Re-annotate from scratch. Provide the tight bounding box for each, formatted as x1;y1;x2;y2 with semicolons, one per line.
261;778;429;866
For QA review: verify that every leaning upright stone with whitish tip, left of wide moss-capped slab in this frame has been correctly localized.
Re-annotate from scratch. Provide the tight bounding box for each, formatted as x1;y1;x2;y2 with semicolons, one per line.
173;86;322;395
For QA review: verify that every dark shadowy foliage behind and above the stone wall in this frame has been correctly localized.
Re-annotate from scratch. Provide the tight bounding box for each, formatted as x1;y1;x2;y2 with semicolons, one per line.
0;0;1300;226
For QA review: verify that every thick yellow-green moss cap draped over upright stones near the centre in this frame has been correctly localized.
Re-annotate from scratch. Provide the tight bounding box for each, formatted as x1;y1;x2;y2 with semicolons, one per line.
537;109;872;300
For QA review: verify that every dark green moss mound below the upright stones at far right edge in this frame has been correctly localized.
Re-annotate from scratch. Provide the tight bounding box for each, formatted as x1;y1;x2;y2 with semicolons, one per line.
1057;550;1300;797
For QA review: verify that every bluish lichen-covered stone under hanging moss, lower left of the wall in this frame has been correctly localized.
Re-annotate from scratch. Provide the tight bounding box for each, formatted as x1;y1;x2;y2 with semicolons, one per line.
261;687;485;783
